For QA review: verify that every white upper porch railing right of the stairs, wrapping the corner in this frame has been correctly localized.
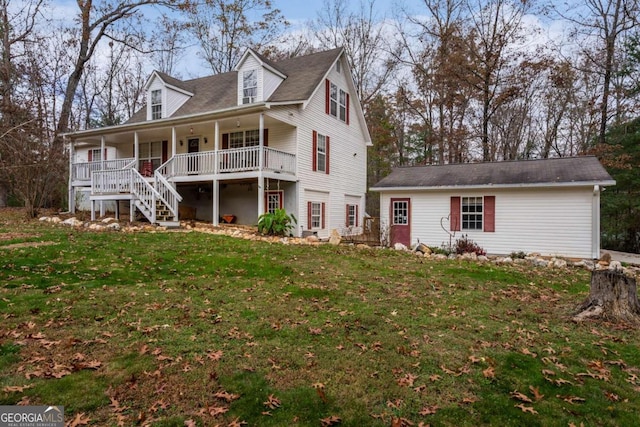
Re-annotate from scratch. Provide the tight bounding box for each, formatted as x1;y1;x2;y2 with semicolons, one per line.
158;147;296;177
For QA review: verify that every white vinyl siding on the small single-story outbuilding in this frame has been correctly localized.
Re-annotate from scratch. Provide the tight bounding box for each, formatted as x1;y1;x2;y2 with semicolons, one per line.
380;186;594;258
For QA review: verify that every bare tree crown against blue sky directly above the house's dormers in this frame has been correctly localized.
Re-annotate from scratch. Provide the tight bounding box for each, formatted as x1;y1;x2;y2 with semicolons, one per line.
186;0;289;74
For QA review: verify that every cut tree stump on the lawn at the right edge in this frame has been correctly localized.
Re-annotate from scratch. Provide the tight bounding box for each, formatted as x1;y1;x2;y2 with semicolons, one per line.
573;270;640;324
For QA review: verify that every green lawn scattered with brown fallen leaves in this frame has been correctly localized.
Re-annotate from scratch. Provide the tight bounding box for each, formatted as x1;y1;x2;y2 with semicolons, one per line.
0;211;640;426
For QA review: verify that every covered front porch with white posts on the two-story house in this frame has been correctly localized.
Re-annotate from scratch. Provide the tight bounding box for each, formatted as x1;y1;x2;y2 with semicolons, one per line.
69;112;297;224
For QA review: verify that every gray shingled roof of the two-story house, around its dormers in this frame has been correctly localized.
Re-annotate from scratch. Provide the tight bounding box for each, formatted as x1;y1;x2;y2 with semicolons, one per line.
127;48;342;123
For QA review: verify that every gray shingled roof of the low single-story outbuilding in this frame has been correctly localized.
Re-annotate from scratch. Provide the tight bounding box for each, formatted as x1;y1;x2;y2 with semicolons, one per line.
372;156;614;190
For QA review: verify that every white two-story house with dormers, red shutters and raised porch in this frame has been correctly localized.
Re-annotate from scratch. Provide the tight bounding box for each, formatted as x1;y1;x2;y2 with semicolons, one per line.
66;49;371;238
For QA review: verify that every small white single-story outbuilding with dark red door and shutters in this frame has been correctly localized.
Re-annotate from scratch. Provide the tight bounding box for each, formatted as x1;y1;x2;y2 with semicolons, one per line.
371;156;615;258
